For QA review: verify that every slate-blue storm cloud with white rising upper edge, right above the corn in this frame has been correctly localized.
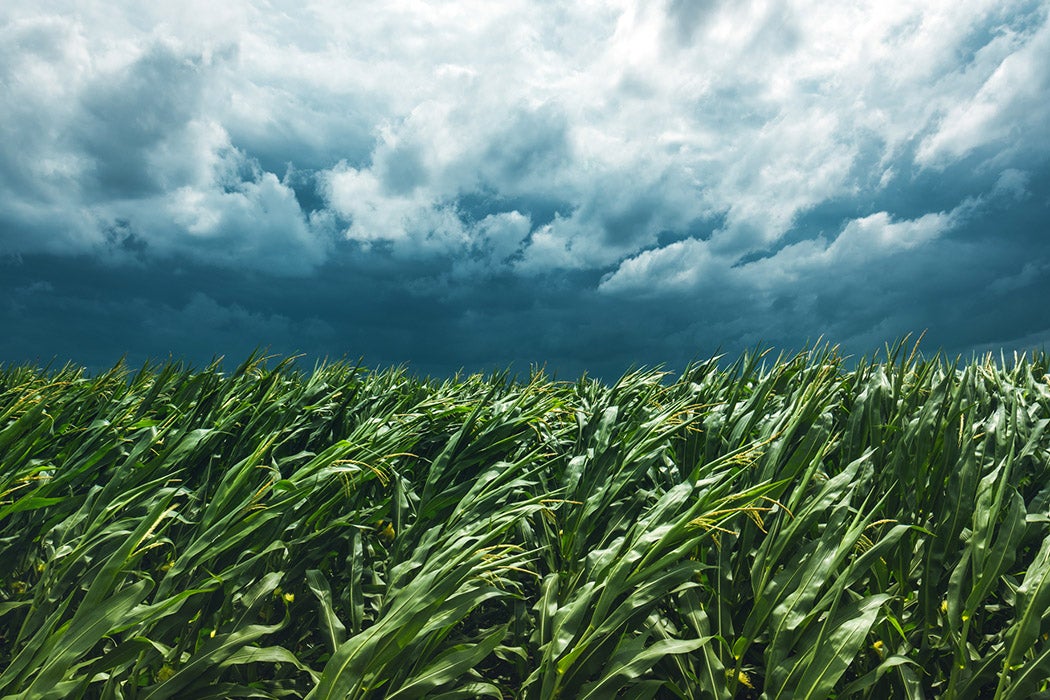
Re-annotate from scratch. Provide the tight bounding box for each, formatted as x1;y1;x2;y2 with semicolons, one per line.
604;159;1050;355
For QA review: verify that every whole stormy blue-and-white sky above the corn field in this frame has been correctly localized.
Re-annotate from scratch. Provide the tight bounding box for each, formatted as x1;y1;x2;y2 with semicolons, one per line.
0;0;1050;378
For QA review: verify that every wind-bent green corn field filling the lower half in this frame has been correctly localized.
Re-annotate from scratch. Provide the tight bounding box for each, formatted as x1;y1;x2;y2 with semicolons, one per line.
0;342;1050;700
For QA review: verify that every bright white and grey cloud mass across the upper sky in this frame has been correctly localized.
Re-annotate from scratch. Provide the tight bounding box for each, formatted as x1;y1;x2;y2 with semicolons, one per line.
0;0;1050;289
